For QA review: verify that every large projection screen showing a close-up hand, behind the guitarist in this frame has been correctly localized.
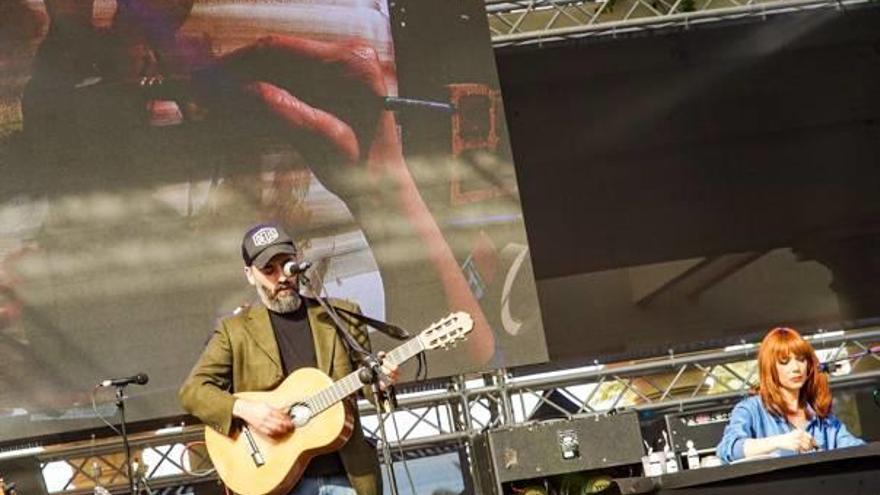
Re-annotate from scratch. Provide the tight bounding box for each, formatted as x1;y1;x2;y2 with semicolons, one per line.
0;0;547;442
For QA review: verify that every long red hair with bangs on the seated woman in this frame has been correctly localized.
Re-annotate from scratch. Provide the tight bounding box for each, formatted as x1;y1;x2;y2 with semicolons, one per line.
758;327;831;418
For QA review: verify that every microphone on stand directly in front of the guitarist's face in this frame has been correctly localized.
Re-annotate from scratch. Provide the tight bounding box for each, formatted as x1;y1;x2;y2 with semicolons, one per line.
299;272;399;495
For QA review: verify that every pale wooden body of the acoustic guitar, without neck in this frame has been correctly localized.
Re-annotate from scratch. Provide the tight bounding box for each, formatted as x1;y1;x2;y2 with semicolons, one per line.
205;368;354;495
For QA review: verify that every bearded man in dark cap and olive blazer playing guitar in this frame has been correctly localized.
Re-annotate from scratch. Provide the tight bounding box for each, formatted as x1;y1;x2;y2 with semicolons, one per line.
180;224;397;495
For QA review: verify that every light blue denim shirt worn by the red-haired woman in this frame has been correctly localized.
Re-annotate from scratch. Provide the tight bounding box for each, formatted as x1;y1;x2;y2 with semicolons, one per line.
715;395;865;464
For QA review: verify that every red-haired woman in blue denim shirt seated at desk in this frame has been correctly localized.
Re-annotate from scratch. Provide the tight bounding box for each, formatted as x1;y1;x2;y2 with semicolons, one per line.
716;327;864;463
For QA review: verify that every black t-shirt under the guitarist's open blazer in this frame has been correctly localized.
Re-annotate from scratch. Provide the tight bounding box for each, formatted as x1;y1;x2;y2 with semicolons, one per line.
269;301;345;477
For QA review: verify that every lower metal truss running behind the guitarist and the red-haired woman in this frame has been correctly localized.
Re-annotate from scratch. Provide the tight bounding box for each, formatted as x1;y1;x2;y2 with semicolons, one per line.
18;327;880;495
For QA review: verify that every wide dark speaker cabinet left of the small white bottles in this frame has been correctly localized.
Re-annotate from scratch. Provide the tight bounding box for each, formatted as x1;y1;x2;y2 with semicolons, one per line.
472;412;643;494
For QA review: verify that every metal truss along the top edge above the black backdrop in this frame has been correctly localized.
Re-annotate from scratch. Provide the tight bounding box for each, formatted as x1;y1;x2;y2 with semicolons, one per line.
485;0;873;47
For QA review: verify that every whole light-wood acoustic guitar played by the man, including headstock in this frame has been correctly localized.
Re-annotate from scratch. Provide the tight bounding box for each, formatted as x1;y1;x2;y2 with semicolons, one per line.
205;312;474;495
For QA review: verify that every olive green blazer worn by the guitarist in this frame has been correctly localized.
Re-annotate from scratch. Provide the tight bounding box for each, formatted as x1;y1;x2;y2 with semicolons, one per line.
179;300;381;495
